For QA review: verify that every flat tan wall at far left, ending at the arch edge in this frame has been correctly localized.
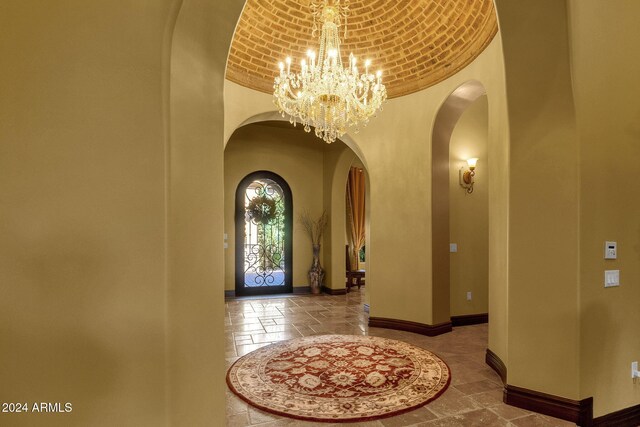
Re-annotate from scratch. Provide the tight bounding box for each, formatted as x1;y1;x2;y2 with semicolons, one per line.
0;0;175;426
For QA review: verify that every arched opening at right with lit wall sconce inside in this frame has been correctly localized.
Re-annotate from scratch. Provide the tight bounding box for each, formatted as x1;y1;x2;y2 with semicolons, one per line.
431;81;488;326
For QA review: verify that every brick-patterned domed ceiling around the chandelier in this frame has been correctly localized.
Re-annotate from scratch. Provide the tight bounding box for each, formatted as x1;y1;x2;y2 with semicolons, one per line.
226;0;498;98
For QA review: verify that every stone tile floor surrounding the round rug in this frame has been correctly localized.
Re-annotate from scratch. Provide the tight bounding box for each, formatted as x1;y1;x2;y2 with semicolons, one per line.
225;288;574;427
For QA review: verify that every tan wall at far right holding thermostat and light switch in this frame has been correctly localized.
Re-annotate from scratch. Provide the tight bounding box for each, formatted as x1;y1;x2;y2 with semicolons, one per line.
569;0;640;416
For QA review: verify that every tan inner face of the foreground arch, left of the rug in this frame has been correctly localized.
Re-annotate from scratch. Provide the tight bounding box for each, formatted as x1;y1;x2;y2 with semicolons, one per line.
166;0;243;426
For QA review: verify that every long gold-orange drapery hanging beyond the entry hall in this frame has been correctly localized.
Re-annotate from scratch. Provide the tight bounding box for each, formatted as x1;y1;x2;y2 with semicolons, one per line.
347;167;365;270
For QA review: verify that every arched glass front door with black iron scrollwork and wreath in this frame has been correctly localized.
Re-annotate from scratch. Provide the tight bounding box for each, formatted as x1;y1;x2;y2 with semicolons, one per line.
235;171;293;296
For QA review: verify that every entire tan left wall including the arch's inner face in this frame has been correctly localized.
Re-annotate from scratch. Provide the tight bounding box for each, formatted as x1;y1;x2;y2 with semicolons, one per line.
0;0;242;426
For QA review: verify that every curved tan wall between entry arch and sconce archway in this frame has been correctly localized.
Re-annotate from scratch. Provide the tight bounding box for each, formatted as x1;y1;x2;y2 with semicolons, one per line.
358;39;508;332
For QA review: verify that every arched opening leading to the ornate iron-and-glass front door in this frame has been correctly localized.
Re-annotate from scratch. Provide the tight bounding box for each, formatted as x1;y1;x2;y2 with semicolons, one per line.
224;120;369;297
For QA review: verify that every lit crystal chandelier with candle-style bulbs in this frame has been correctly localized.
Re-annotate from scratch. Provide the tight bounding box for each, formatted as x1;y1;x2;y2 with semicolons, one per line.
273;0;387;143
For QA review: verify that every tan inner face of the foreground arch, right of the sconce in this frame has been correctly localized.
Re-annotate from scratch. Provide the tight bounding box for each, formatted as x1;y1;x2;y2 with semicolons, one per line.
498;0;580;399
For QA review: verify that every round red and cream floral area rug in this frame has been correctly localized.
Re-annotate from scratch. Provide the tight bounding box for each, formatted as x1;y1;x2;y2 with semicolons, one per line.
227;335;451;422
